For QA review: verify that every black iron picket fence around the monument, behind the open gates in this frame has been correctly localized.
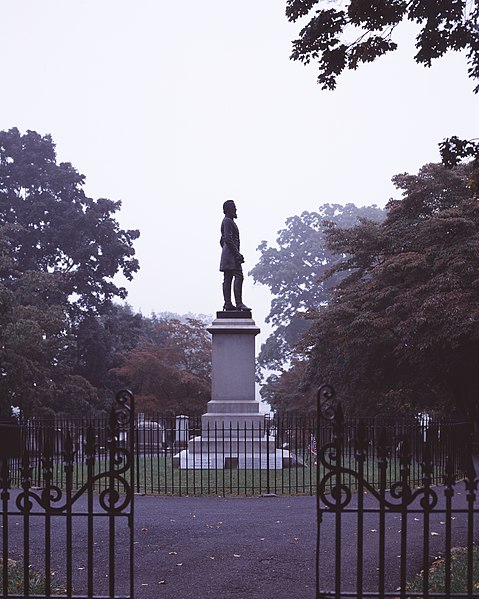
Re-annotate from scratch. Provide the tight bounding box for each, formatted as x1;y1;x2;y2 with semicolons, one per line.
10;414;468;495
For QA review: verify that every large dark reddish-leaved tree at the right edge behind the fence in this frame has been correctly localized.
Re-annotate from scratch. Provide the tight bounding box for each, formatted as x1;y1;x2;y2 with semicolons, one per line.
303;164;479;422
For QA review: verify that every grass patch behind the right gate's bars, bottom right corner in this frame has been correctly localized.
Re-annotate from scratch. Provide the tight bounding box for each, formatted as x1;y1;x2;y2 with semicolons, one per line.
407;546;479;599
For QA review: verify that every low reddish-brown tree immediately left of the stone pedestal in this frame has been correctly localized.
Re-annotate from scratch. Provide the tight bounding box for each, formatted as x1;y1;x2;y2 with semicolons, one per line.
113;318;211;415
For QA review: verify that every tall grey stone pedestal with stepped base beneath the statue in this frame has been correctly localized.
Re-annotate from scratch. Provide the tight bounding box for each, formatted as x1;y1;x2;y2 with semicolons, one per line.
176;311;284;469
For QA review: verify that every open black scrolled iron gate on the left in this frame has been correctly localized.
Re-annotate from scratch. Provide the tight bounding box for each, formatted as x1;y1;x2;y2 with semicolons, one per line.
0;391;135;599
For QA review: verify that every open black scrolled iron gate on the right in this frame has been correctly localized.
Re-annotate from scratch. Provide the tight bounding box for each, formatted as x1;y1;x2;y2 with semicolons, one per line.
316;385;479;599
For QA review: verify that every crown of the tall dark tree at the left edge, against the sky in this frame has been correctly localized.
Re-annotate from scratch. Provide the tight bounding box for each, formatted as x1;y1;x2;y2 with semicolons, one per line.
0;128;139;319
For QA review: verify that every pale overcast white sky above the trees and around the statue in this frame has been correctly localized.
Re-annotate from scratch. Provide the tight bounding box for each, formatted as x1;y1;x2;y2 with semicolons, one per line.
0;0;479;344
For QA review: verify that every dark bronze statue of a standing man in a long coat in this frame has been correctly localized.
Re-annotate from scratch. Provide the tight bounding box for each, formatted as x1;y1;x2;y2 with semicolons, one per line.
220;200;251;311
